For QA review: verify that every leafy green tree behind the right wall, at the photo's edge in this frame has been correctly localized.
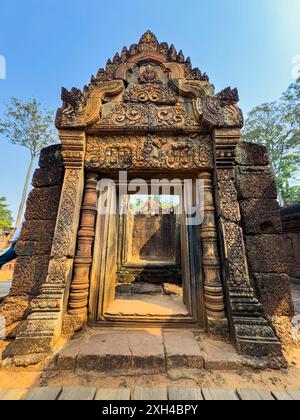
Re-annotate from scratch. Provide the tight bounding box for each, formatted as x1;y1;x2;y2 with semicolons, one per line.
243;79;300;203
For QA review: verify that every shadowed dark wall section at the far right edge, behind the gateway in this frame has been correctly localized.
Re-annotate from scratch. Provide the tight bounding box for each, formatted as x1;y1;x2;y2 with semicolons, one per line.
281;203;300;284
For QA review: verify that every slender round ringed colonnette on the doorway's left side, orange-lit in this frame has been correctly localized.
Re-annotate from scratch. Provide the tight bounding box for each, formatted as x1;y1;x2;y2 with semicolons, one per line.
68;173;99;323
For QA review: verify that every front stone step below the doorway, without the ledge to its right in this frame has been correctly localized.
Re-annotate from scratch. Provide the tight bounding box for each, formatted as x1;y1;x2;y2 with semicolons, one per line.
54;329;203;376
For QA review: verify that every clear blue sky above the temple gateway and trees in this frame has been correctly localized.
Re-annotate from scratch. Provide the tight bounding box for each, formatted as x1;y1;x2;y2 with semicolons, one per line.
0;0;300;221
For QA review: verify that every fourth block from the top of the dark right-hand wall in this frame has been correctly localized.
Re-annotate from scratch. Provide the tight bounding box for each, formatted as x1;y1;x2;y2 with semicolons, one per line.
246;235;285;273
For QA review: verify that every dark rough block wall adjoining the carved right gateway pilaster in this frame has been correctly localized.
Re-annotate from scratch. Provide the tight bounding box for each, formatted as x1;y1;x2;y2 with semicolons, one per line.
237;143;294;345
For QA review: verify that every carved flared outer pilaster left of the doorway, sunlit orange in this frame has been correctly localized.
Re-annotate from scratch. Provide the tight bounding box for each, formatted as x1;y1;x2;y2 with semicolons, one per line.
7;130;86;364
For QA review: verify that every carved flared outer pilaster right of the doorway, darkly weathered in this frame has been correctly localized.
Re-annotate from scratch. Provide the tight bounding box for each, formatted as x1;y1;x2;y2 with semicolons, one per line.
213;129;282;357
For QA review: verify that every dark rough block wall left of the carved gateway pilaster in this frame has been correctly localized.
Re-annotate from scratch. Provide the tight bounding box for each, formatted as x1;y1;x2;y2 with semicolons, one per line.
0;145;64;325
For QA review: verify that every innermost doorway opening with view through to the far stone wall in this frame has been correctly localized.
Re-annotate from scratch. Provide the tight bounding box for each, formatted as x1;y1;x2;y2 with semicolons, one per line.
107;194;189;318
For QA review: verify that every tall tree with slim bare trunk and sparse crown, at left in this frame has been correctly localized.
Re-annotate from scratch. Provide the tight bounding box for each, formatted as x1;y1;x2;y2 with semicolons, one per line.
0;98;58;226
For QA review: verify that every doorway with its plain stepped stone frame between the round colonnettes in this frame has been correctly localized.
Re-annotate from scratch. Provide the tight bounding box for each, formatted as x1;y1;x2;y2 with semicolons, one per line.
90;175;205;329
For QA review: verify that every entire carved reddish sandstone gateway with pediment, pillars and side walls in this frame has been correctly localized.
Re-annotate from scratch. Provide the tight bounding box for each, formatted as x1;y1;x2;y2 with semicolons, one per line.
0;32;293;365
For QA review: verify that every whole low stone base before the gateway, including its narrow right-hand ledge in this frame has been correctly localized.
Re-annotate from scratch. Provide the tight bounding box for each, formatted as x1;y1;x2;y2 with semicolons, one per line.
43;329;285;380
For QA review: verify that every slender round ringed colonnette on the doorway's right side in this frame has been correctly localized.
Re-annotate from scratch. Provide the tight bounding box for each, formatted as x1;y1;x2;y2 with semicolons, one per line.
200;172;229;338
